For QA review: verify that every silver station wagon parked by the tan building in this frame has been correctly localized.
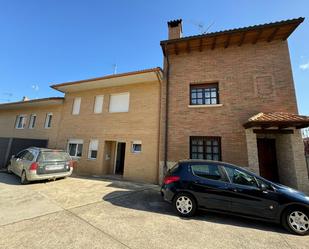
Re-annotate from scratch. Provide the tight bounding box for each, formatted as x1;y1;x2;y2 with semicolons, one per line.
8;147;73;184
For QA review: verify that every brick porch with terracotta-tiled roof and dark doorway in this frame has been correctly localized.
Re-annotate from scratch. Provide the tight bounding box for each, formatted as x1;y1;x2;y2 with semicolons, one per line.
244;112;309;193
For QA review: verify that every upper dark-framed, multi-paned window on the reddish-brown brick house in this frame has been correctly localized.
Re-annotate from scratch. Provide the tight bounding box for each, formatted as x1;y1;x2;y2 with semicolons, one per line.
190;83;219;105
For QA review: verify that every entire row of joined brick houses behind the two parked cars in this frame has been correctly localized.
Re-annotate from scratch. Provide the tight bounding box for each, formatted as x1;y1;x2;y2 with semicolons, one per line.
0;18;309;189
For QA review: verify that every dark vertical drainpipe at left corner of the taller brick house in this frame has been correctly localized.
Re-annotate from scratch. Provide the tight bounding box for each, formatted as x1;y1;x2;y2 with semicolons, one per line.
163;44;170;175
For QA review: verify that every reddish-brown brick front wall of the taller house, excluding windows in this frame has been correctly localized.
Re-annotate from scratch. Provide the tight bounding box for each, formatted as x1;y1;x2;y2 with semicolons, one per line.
160;41;297;169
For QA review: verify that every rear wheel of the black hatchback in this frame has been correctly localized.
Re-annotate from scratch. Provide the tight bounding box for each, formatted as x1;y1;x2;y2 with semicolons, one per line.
173;193;197;217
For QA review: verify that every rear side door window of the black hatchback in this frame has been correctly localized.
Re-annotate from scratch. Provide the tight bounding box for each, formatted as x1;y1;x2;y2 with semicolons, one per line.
191;164;226;181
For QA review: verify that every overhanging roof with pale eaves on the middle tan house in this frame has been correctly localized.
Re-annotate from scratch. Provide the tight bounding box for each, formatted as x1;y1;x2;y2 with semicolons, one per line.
51;67;162;92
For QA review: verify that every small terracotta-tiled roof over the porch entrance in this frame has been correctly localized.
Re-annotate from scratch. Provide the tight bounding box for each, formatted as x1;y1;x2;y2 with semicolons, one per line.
244;112;309;128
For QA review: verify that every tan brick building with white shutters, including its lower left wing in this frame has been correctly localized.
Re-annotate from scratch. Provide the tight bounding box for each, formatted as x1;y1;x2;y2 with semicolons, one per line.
0;68;162;183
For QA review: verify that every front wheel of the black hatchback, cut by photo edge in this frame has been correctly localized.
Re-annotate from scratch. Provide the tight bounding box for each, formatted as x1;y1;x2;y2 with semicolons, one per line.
281;207;309;235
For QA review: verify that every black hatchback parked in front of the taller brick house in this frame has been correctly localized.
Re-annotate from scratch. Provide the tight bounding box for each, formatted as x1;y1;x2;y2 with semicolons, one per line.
161;160;309;235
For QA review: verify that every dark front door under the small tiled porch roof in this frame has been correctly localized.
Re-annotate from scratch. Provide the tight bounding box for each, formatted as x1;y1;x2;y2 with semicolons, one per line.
257;138;279;182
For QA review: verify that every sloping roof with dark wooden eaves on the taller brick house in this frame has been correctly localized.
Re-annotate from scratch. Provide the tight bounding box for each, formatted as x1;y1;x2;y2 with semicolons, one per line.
160;17;305;54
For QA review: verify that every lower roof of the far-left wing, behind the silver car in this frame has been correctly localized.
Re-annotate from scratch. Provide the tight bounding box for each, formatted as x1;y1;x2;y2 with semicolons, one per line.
0;97;64;110
